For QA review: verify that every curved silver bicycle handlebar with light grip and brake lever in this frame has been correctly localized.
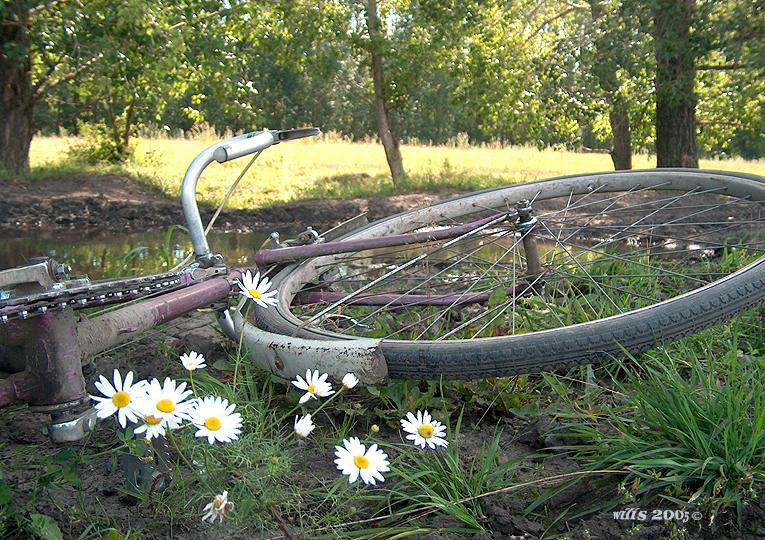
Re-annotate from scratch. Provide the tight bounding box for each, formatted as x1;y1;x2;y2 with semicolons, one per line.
181;128;321;267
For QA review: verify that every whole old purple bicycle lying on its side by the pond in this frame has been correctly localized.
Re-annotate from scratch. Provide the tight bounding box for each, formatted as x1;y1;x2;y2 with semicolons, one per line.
0;128;765;442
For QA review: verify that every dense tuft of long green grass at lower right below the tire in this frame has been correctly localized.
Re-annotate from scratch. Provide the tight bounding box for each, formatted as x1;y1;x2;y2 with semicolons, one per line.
531;310;765;528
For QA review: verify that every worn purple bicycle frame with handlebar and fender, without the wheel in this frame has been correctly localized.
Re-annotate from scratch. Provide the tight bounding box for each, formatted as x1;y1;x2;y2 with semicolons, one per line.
0;128;544;442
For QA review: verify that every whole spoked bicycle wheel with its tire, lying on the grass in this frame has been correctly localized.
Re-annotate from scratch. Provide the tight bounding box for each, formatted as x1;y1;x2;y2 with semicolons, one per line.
254;169;765;379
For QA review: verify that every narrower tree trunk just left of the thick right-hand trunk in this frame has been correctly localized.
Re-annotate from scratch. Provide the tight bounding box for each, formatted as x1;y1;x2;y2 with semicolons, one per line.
590;0;632;171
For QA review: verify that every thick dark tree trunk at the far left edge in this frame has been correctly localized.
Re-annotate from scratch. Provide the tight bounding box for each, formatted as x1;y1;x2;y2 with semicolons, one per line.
0;0;34;174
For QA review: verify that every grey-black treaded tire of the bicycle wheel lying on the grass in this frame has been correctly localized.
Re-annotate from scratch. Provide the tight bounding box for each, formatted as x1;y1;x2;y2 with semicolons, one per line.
255;169;765;379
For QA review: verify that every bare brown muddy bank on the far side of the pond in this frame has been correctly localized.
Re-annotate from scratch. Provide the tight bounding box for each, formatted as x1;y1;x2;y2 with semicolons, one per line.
0;175;444;232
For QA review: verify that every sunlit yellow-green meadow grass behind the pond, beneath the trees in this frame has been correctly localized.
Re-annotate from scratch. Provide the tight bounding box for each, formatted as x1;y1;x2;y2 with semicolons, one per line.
23;134;765;208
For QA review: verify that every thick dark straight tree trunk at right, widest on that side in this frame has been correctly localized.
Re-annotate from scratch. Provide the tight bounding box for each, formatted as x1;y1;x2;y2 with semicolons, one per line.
651;0;699;168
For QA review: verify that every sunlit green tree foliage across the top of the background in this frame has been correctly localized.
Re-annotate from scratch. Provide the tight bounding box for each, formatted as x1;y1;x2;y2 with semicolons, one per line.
13;0;765;159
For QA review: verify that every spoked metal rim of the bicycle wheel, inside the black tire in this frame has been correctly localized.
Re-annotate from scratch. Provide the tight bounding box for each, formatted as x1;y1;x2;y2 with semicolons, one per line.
259;171;765;342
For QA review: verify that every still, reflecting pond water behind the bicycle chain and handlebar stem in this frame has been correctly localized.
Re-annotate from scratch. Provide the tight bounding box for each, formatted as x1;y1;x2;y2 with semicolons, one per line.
0;229;292;279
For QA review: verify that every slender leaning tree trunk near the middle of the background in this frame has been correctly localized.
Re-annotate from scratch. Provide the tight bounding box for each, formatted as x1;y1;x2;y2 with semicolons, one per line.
367;0;405;186
